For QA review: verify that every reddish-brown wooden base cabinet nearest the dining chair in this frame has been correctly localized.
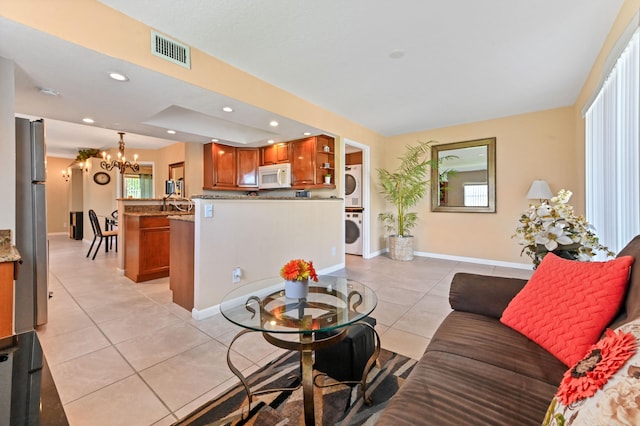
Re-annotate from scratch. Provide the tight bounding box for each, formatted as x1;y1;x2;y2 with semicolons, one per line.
124;215;171;283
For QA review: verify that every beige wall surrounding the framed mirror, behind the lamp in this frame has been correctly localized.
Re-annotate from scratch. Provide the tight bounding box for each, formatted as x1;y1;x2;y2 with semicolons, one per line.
374;108;577;263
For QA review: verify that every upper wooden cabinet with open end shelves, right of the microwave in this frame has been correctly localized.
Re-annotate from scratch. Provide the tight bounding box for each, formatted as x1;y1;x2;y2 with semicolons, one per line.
289;135;335;189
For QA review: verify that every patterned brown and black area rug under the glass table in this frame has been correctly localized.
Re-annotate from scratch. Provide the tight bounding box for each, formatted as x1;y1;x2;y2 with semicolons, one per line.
174;349;416;426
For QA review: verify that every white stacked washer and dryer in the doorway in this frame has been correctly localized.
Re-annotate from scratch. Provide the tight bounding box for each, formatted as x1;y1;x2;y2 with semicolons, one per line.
344;164;364;255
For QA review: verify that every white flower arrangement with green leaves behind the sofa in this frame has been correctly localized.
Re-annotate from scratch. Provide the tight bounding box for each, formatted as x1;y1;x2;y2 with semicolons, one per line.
513;189;615;266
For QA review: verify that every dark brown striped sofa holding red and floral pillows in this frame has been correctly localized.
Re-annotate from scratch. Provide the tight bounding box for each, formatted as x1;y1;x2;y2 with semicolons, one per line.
376;236;640;426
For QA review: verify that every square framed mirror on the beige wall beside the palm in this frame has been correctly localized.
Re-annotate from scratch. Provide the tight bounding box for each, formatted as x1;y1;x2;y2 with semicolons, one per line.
431;138;496;213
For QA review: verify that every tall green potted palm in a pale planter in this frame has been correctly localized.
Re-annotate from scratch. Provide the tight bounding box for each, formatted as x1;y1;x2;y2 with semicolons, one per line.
378;141;434;260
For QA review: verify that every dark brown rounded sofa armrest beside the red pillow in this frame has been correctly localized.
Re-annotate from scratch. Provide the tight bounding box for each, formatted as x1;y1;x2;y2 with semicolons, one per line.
449;272;527;318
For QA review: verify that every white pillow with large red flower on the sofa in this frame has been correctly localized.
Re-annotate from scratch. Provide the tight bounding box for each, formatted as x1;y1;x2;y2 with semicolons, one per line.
542;319;640;426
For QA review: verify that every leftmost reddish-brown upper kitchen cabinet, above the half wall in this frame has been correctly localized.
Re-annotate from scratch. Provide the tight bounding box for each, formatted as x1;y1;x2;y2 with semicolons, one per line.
203;143;237;189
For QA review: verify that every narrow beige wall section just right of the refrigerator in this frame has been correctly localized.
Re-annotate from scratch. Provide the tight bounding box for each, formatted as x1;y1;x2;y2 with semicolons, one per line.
46;157;72;233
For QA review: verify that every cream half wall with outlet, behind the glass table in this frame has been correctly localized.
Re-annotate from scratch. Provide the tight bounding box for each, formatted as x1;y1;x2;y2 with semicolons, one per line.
194;199;345;312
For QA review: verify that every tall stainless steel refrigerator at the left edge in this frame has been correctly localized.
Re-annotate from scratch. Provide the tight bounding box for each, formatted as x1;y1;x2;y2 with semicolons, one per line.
15;118;49;333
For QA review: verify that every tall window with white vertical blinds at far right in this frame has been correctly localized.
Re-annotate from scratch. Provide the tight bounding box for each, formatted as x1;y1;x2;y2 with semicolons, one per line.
585;29;640;252
